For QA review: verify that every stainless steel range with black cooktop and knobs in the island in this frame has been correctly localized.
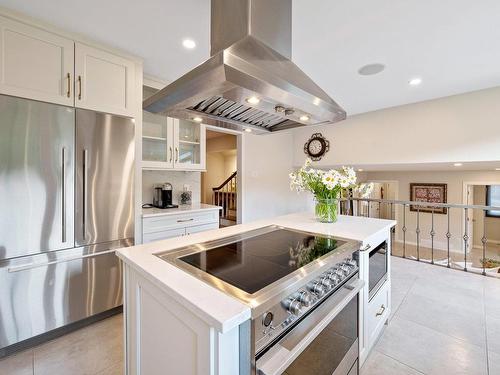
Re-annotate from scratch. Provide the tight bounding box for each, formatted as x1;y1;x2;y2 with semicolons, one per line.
158;226;363;375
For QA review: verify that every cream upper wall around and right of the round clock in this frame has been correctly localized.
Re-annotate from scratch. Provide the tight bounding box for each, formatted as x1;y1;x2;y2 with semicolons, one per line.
293;87;500;166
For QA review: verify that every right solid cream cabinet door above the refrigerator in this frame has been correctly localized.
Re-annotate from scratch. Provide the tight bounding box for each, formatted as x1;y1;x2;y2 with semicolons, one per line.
75;43;135;117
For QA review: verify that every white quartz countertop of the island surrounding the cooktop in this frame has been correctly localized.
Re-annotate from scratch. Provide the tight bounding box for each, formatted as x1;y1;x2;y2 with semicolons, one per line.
117;213;396;333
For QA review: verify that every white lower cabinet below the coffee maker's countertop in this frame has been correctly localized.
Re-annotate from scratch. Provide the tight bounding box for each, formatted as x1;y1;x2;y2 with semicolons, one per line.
142;209;219;243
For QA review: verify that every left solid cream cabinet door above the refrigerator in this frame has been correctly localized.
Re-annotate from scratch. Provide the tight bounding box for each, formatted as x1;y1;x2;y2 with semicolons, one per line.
0;17;74;106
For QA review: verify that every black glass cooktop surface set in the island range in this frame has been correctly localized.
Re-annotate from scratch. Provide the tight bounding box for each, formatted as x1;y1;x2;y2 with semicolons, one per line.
179;229;346;294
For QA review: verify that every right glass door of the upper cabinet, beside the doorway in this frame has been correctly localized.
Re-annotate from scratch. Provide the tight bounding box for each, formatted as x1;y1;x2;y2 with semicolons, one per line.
174;119;206;170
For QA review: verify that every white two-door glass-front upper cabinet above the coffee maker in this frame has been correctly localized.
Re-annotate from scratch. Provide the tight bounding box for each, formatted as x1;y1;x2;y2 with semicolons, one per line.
142;86;205;170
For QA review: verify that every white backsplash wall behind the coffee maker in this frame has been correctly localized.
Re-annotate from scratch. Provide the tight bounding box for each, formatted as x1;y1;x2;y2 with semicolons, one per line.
142;170;201;204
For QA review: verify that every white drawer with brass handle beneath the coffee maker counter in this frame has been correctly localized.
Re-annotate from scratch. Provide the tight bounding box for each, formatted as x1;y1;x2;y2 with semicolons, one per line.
143;210;219;233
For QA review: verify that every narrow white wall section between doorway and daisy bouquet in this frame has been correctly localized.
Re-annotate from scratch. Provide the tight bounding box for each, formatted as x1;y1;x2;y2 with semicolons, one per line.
238;132;311;223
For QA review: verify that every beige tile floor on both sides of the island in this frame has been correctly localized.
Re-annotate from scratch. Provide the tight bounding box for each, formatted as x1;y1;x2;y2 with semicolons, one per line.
0;257;500;375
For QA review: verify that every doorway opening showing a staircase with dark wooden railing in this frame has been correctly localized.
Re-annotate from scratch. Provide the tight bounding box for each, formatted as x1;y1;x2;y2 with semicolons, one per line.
201;127;241;227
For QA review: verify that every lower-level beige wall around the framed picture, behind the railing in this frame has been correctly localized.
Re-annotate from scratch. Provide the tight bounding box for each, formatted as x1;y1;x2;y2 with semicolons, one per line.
365;171;500;252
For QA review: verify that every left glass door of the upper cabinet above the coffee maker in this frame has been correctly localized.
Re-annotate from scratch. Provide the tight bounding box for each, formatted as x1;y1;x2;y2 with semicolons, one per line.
142;86;174;169
